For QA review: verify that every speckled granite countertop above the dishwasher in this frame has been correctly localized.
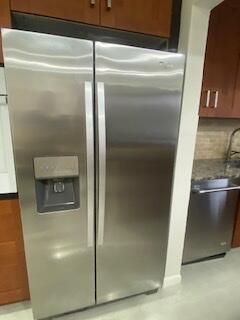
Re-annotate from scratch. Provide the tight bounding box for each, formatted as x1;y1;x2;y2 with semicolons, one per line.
192;159;240;181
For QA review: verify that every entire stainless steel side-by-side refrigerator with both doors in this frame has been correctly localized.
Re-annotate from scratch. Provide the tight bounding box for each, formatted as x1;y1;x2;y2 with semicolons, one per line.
2;29;184;318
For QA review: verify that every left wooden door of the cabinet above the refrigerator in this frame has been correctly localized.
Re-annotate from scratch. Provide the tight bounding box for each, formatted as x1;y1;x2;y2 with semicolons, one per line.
10;0;100;24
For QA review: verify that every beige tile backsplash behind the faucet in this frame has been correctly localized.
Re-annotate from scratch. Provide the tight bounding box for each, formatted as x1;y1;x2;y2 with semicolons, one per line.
194;119;240;159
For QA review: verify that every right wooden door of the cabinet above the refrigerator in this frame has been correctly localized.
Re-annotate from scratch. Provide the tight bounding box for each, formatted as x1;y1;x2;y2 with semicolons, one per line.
100;0;172;37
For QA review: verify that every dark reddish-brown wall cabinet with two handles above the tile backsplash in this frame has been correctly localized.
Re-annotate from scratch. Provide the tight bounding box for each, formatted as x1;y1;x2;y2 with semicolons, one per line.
200;0;240;118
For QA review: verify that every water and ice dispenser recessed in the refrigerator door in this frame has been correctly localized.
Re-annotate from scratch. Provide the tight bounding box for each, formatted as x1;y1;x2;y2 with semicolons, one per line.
33;156;80;213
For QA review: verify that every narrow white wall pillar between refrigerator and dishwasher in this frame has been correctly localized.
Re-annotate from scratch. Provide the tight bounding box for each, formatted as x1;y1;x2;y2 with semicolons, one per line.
164;0;222;287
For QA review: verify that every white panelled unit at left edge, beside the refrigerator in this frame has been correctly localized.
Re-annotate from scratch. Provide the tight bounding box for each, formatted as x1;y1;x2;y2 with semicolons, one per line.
0;68;17;194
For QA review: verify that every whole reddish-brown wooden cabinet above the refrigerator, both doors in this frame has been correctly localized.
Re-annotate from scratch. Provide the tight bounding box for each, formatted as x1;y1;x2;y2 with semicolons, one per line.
10;0;173;38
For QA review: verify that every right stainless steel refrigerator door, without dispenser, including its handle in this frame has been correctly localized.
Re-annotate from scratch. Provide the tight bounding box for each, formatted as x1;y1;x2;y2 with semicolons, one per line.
95;43;184;303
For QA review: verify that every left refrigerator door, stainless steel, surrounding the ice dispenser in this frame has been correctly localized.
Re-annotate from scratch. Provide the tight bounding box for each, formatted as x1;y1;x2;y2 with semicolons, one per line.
3;30;95;318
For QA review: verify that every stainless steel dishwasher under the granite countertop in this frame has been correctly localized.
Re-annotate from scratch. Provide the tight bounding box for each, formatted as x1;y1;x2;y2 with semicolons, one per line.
183;179;240;263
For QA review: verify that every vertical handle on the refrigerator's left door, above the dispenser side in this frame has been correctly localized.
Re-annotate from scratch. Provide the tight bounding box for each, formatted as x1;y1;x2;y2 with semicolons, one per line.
85;81;94;247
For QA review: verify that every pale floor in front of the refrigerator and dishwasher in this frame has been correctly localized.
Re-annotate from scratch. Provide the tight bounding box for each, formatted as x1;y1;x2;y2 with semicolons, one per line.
0;249;240;320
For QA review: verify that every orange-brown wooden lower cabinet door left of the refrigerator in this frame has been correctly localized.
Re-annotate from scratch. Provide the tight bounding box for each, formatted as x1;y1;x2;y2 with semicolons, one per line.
0;199;29;305
